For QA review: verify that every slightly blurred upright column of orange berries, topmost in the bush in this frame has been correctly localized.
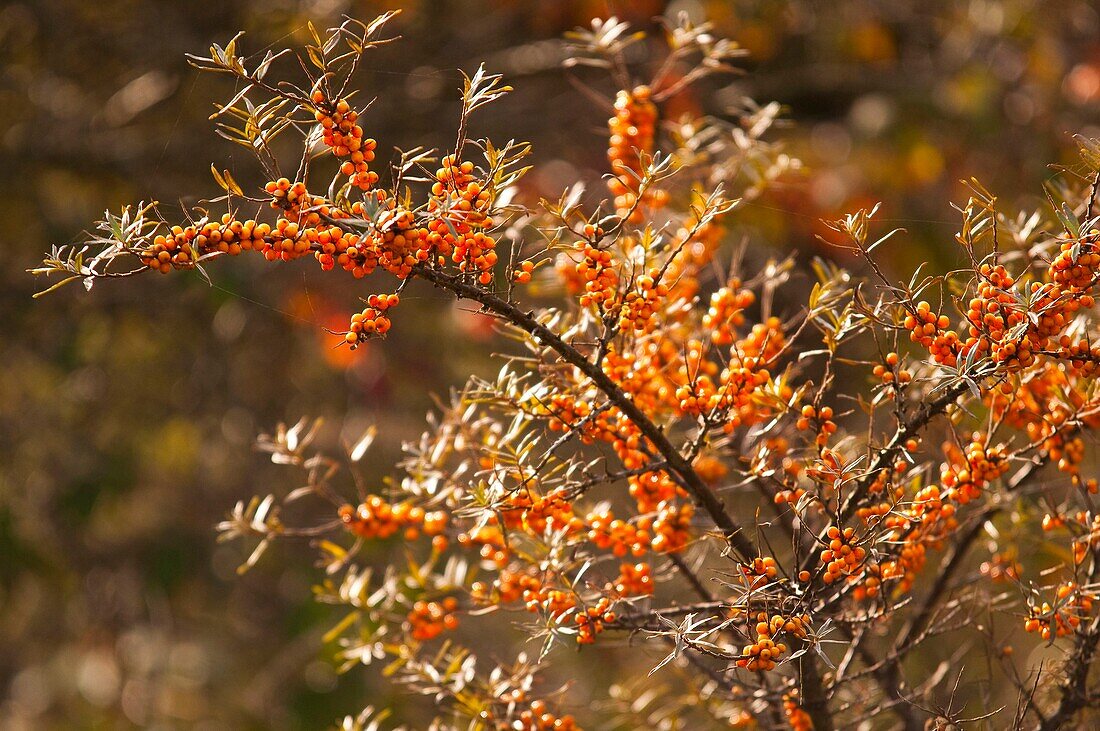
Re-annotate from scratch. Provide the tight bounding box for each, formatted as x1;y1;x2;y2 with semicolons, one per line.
607;86;668;217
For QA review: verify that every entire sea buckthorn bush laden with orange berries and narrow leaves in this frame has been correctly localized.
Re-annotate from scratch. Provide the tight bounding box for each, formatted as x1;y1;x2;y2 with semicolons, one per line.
35;8;1100;731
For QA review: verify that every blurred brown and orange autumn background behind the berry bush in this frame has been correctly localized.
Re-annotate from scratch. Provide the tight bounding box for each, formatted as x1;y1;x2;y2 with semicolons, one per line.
0;0;1100;729
